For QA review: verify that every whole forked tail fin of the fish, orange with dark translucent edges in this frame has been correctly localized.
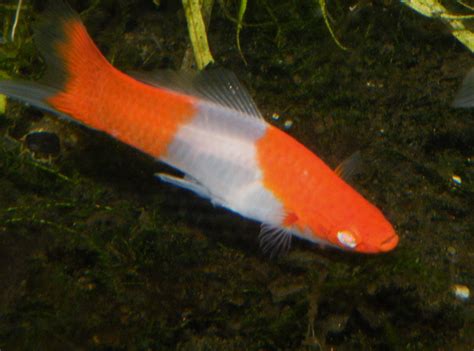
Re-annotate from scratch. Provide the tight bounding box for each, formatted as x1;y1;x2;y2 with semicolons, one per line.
0;0;113;127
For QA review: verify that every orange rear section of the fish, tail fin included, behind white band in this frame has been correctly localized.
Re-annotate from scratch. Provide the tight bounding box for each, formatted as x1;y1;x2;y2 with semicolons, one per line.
0;0;196;158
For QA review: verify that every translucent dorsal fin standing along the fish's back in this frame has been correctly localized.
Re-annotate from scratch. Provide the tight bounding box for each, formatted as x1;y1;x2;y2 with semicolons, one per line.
131;68;263;119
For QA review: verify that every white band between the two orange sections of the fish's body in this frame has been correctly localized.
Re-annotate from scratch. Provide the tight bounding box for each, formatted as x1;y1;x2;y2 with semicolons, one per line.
161;102;284;226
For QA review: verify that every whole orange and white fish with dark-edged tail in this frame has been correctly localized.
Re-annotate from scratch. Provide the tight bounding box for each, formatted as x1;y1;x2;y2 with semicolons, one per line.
0;1;399;254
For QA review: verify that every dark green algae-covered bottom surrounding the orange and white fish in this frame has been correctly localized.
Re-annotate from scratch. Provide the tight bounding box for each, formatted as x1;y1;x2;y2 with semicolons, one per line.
0;0;474;350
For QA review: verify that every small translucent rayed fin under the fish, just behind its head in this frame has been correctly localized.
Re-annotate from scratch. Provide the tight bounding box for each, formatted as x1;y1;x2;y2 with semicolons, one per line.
258;224;292;257
